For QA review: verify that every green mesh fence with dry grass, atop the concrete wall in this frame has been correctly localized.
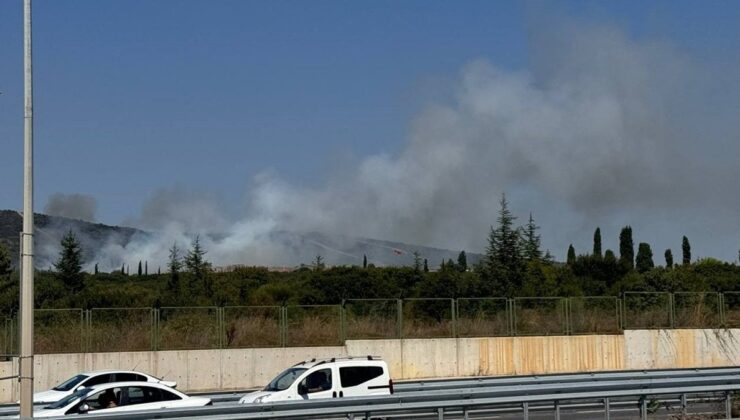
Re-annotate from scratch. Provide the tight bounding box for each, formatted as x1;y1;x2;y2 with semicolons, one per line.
0;292;740;354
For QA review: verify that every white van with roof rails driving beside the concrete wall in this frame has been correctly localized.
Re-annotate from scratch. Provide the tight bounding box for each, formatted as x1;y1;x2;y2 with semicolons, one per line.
239;356;393;404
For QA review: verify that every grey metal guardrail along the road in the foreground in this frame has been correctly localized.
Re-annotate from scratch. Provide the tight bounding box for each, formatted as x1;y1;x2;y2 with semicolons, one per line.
43;375;740;420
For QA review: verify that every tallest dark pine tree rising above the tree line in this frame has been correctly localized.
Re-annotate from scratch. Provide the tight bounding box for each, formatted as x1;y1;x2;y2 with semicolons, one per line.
486;194;524;296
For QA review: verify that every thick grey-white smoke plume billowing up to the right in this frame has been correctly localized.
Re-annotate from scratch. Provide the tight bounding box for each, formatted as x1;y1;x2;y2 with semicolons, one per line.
92;19;740;265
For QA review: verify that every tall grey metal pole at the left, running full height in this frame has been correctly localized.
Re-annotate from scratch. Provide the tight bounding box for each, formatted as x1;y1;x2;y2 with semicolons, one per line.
18;0;34;419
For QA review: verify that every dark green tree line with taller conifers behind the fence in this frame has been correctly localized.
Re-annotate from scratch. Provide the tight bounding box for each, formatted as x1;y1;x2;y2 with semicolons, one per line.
0;196;740;313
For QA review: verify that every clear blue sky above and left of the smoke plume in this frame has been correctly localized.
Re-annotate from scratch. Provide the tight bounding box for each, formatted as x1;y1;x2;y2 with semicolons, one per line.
0;0;740;259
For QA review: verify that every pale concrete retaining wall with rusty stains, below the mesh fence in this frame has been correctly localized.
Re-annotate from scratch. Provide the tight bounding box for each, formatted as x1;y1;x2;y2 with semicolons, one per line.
0;329;740;403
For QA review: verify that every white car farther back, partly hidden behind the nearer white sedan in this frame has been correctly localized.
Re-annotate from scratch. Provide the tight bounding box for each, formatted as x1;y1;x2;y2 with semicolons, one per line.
33;370;177;404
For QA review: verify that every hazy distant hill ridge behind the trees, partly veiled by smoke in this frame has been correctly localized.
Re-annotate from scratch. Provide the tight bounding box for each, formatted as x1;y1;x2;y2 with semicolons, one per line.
0;210;481;269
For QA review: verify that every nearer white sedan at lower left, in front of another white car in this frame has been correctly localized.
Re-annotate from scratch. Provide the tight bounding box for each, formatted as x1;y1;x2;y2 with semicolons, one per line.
33;382;212;418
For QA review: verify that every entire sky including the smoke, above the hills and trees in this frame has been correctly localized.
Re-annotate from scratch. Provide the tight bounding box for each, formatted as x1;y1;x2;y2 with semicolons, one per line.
0;0;740;264
